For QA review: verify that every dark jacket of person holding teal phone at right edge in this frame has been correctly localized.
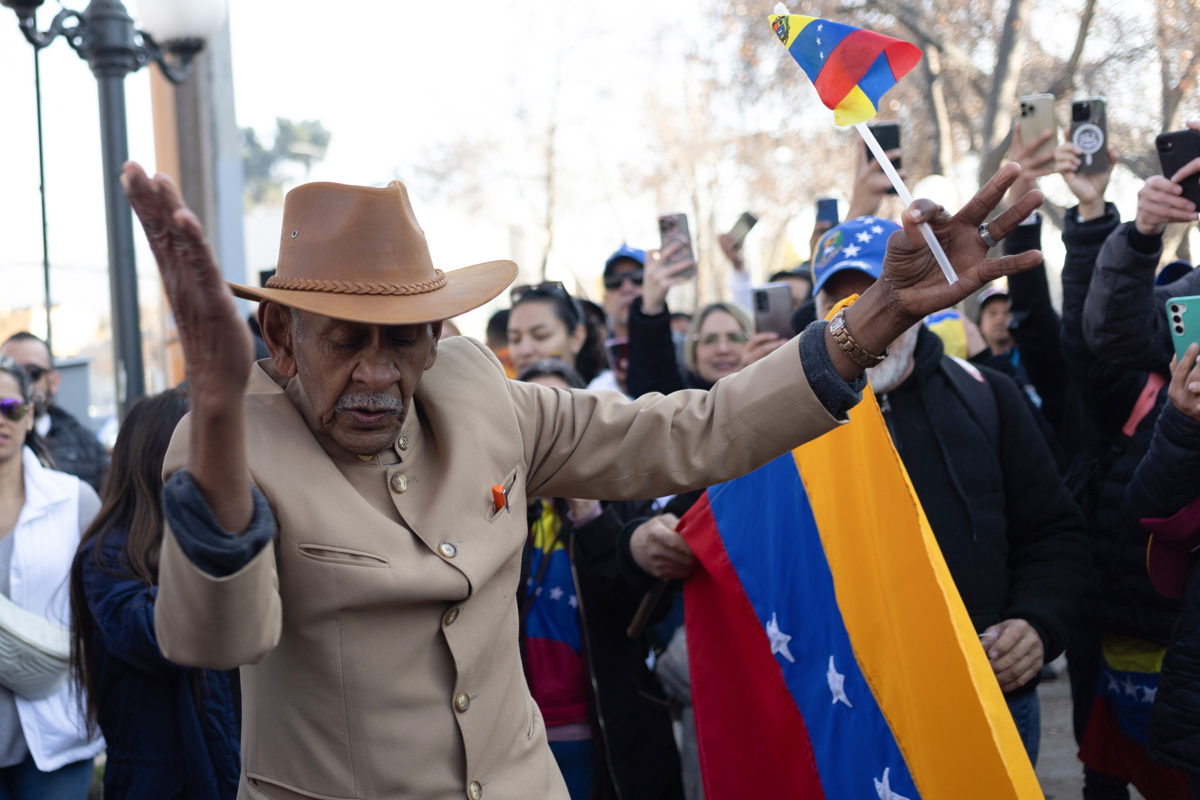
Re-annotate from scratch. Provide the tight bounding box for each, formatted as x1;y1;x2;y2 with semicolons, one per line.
1126;403;1200;775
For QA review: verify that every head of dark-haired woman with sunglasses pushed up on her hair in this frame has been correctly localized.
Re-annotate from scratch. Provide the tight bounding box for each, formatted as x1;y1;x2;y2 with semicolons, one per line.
509;282;604;383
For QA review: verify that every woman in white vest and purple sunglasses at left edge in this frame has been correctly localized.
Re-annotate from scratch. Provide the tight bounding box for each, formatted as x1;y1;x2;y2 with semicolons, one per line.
0;356;104;800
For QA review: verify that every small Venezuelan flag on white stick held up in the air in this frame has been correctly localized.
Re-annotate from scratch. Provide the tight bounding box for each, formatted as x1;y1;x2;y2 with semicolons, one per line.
770;6;920;125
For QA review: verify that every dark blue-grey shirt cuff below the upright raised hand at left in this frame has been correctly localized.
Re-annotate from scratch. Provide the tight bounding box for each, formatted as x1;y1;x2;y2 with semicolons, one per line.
162;469;276;578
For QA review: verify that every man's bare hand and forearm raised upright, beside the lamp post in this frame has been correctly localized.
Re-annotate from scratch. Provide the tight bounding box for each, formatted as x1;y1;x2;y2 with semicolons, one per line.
121;162;254;534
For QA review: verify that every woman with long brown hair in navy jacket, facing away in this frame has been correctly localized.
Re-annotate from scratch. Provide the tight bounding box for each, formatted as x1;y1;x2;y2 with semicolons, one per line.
71;389;240;800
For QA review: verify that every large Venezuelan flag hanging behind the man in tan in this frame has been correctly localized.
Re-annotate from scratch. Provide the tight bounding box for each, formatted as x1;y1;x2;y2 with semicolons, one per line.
680;371;1042;800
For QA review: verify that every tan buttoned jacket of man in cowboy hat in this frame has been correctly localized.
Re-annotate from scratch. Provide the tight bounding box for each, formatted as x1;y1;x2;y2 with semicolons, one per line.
155;337;838;800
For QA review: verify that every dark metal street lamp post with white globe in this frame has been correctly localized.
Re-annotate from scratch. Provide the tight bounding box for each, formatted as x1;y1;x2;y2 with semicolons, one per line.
0;0;226;419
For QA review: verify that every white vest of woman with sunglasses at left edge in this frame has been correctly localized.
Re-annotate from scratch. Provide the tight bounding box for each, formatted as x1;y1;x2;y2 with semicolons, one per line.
8;447;104;772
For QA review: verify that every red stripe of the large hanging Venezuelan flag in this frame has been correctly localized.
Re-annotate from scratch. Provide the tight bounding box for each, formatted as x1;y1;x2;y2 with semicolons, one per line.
680;493;824;800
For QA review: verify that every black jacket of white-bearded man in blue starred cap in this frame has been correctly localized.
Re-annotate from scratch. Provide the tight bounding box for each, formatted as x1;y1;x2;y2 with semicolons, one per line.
880;327;1087;693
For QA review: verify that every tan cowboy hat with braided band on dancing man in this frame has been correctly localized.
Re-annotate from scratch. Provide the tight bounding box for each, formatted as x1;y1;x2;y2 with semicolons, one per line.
229;181;517;325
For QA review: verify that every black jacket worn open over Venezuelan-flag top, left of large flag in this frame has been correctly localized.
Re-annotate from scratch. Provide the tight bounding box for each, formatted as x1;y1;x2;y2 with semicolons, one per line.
521;500;683;800
